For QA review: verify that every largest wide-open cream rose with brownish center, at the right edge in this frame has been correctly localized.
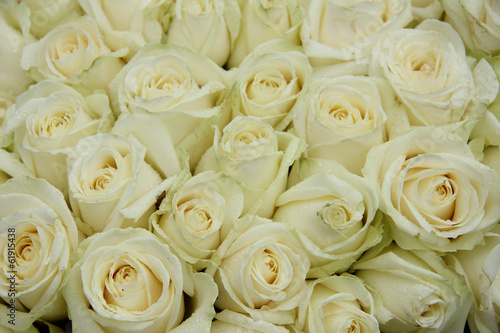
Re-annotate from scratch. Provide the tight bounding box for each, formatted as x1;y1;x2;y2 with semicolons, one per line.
363;127;500;252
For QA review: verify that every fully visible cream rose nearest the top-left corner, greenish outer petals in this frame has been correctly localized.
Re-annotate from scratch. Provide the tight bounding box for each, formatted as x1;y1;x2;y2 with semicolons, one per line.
21;15;126;89
